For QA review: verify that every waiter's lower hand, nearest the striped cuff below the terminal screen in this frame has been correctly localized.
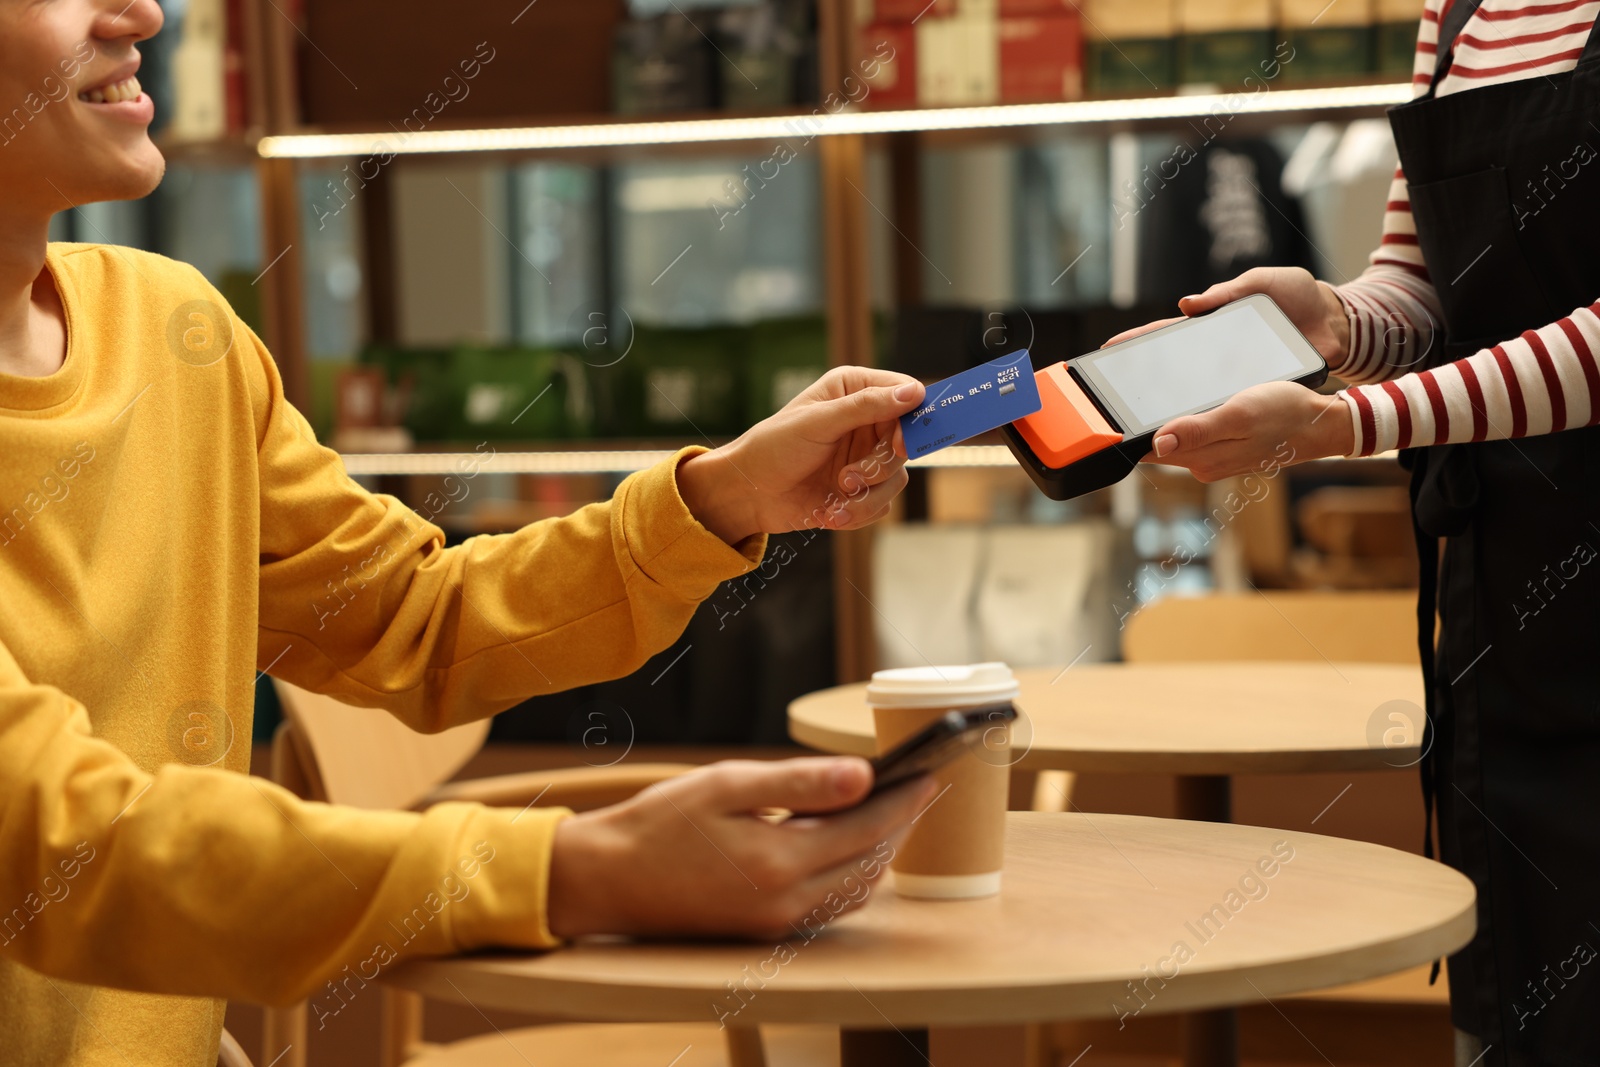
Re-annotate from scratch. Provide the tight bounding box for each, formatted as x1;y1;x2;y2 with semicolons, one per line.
1144;382;1355;482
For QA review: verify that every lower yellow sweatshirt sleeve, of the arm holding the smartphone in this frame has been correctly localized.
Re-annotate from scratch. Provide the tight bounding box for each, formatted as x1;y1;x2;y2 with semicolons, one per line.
0;633;568;1016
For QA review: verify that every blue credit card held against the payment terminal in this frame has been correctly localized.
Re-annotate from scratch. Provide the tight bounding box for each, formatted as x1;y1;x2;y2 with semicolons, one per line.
901;350;1043;459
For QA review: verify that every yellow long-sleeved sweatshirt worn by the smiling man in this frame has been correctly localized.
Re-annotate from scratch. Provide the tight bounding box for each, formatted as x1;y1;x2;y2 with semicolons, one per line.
0;245;765;1067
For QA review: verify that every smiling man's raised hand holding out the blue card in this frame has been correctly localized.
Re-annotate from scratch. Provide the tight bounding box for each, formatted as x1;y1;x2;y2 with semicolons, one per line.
678;366;925;544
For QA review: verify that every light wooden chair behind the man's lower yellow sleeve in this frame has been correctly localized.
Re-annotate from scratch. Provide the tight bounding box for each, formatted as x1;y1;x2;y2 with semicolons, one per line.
262;681;838;1067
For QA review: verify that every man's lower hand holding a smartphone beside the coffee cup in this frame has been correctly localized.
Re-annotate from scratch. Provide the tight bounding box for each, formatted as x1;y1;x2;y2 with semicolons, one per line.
547;757;939;939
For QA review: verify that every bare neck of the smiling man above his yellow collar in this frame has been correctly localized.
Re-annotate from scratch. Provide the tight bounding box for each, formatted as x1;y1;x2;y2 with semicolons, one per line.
0;218;66;378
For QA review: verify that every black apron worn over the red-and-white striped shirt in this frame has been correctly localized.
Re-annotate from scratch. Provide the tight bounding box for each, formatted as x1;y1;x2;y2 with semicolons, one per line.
1389;0;1600;1067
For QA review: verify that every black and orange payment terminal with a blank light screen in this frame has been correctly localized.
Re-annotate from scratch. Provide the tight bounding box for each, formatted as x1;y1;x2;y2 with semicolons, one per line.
1005;296;1328;501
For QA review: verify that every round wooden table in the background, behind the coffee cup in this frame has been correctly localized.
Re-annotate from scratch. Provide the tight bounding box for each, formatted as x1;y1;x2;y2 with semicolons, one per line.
789;662;1424;1067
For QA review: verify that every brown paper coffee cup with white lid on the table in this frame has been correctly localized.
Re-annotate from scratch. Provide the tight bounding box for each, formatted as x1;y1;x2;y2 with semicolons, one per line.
867;664;1018;899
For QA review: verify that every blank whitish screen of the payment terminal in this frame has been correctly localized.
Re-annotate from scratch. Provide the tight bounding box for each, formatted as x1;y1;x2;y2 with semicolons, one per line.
1093;304;1306;430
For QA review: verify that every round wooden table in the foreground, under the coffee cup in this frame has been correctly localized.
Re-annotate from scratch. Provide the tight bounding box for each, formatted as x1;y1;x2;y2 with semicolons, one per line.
382;813;1475;1067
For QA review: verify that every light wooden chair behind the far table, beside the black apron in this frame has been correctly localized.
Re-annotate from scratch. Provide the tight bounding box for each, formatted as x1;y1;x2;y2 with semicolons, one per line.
1122;592;1450;1005
